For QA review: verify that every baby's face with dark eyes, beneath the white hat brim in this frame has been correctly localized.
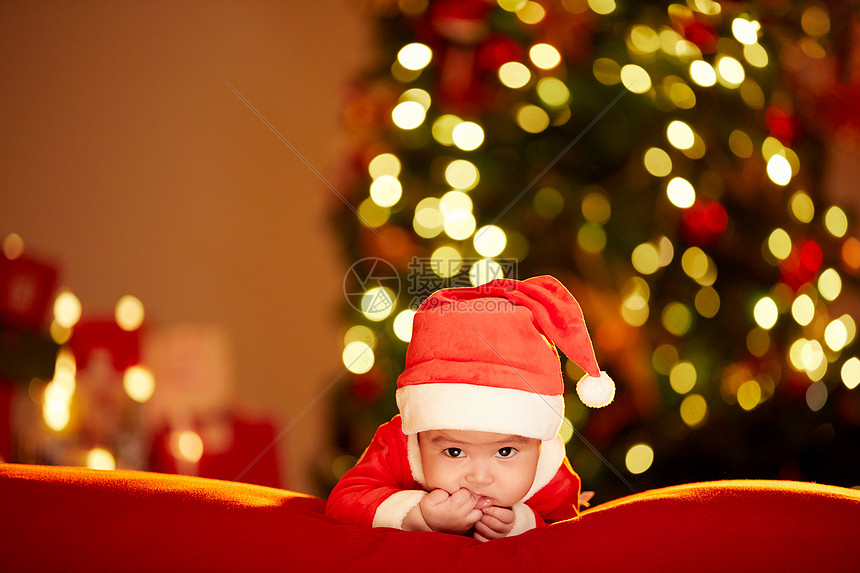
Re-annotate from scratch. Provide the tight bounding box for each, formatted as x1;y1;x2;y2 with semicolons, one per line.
418;430;540;507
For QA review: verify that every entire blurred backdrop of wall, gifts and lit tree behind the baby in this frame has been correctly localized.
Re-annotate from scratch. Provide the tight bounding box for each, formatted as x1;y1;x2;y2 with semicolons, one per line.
0;0;860;503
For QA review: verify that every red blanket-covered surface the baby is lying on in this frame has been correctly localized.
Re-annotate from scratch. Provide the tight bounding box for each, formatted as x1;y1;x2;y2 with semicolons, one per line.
0;464;860;573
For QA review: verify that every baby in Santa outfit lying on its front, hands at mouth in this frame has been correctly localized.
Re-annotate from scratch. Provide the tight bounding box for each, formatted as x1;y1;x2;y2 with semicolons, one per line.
326;276;615;541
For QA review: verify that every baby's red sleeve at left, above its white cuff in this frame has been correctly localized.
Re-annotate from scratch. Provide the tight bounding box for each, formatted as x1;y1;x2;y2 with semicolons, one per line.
326;416;421;526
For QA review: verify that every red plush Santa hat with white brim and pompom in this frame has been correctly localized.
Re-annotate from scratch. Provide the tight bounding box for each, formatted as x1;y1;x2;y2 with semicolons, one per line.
397;276;615;440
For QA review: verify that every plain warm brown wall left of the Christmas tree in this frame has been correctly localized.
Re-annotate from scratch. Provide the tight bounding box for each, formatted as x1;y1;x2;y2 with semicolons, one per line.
0;0;367;491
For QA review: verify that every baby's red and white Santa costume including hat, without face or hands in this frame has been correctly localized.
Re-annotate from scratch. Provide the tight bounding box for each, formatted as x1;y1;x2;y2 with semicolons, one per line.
326;276;615;535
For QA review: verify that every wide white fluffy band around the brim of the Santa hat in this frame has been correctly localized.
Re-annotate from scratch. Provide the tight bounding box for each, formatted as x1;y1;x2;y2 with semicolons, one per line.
396;382;564;441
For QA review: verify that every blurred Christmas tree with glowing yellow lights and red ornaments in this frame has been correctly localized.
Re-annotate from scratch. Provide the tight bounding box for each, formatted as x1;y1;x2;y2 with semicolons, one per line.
320;0;860;501
